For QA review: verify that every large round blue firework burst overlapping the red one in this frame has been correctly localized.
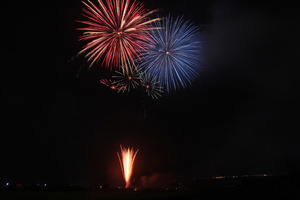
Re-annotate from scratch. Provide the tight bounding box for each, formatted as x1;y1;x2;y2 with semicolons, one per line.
140;16;200;92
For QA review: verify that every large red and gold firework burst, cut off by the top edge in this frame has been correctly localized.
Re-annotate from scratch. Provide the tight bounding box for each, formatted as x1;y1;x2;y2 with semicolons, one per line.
78;0;159;73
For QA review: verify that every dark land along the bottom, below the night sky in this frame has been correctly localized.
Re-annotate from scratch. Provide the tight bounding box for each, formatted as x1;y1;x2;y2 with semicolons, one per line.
0;176;300;200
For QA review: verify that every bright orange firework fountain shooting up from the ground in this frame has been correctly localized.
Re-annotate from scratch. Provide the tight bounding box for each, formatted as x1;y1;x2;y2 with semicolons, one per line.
117;145;139;188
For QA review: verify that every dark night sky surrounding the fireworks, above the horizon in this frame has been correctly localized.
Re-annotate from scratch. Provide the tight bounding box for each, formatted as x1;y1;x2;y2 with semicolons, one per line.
0;0;300;184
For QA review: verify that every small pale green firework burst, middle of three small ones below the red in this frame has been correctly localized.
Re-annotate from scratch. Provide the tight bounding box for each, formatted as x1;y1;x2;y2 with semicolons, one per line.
113;67;140;92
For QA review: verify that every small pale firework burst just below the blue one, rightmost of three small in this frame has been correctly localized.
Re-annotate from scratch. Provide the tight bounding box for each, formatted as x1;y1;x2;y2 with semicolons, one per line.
140;73;163;99
